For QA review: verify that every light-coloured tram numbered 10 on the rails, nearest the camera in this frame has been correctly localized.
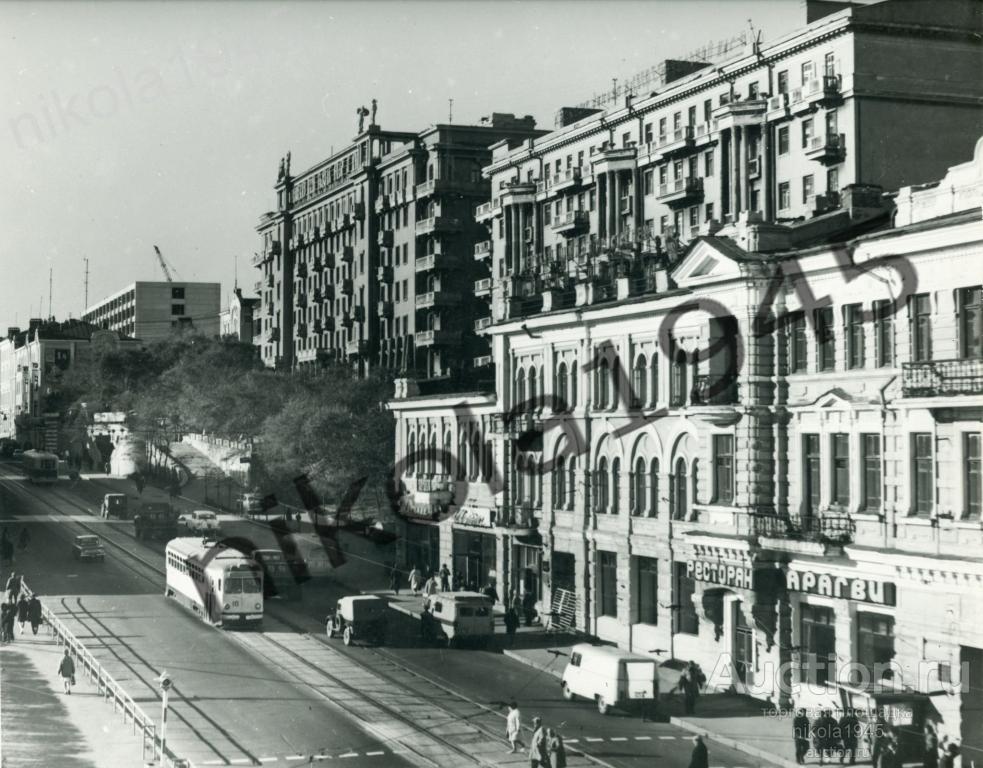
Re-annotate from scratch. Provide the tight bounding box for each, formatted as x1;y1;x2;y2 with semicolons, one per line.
164;537;263;627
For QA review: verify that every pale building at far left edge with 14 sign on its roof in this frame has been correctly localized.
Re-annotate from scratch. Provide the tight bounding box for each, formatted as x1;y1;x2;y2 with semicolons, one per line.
0;318;139;450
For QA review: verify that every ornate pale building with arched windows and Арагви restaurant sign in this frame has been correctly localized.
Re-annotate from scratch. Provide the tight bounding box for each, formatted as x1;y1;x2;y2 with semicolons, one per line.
391;135;983;750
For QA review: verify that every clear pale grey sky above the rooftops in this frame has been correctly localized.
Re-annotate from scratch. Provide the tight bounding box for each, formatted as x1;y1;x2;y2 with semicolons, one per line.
0;0;804;329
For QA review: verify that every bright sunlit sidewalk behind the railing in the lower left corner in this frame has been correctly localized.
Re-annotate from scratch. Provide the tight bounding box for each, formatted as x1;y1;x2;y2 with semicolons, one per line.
0;624;152;768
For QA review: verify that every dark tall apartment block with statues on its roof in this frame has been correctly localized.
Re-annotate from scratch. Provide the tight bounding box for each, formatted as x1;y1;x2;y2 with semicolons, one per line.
254;113;543;377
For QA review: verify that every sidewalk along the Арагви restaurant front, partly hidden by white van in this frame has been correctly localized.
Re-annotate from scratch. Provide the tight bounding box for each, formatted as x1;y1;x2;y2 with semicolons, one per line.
505;641;818;768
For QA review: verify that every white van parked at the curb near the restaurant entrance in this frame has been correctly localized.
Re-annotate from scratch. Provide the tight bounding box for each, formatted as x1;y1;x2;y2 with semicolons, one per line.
562;643;659;715
